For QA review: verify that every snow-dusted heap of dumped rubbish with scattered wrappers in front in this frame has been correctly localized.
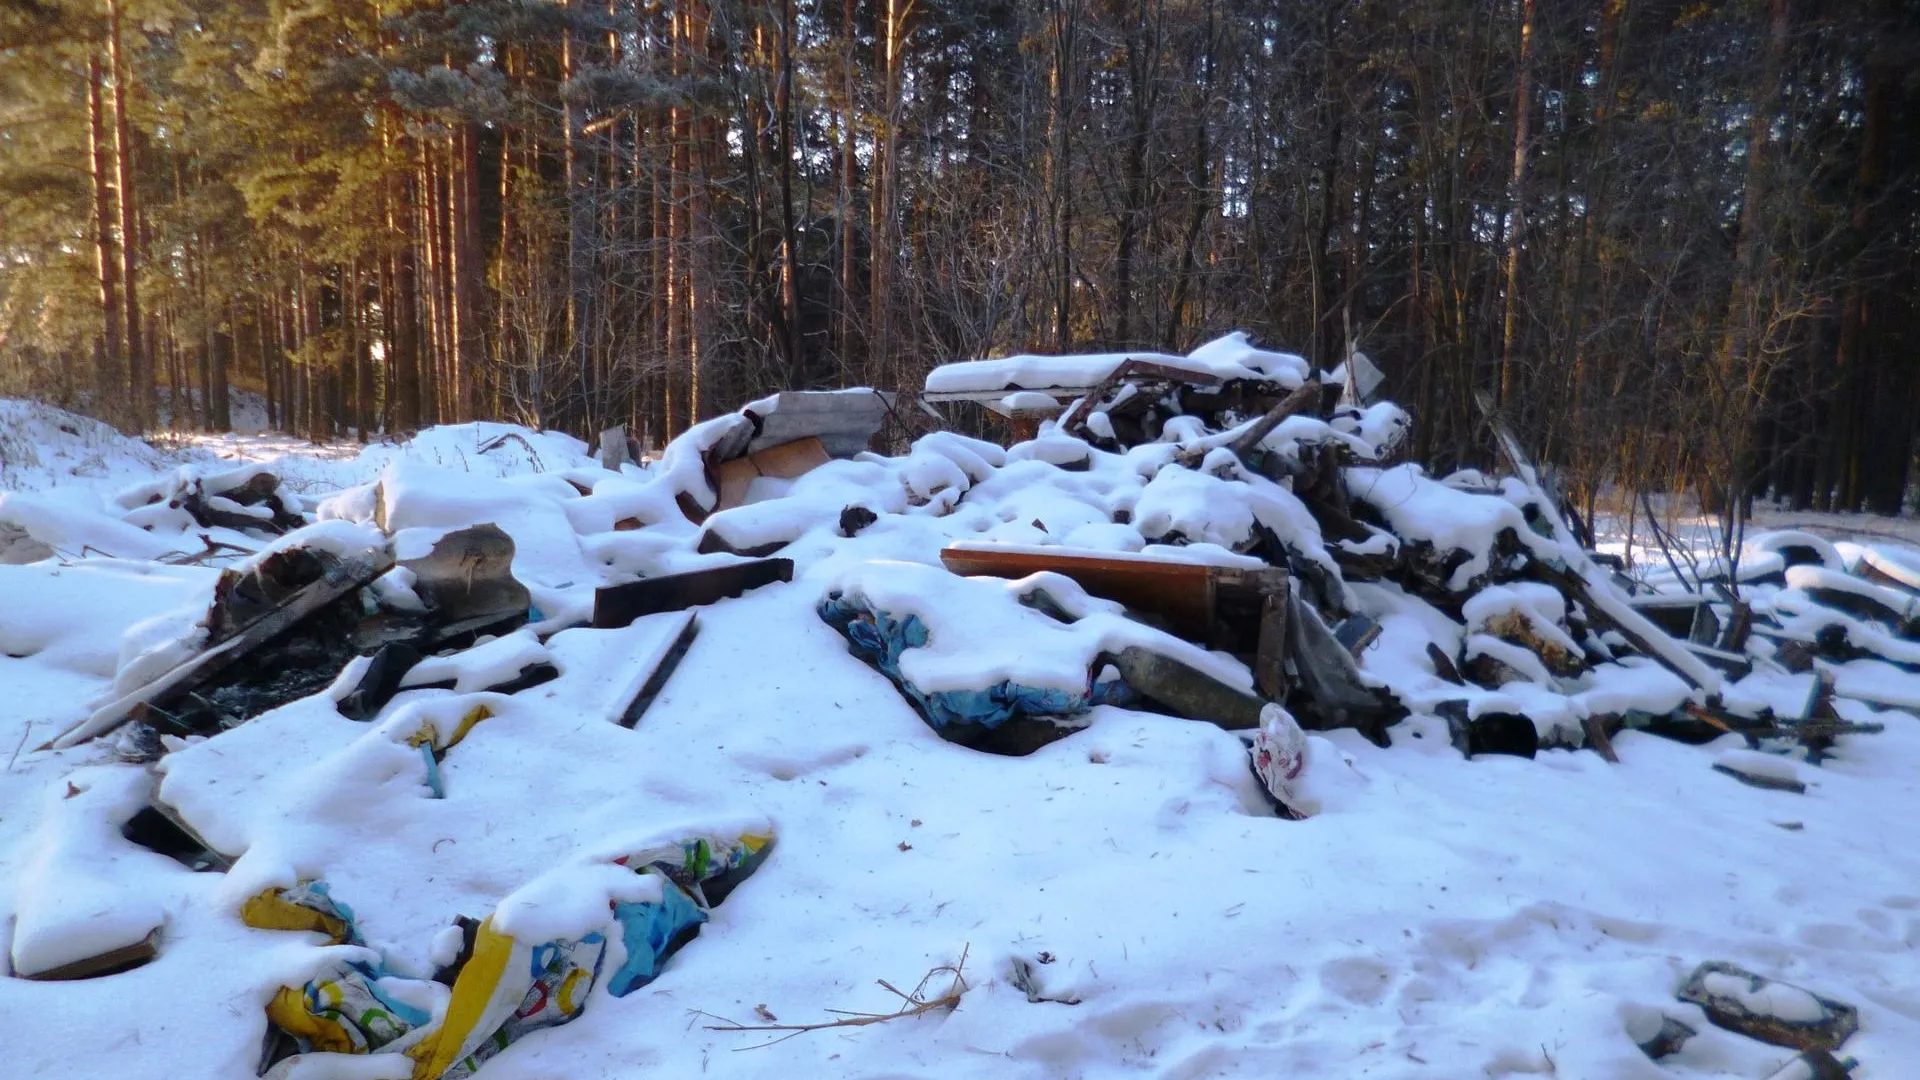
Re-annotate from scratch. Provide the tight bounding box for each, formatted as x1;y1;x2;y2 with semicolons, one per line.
18;334;1920;1076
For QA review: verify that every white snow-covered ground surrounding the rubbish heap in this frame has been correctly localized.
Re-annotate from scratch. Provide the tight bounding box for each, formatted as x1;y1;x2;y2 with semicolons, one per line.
0;402;1920;1080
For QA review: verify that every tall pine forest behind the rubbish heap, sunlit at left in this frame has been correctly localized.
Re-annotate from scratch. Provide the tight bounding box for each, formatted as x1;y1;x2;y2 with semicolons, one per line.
0;0;1920;513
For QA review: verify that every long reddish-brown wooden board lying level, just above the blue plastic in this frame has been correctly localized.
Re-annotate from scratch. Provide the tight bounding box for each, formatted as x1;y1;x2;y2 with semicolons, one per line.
941;542;1288;642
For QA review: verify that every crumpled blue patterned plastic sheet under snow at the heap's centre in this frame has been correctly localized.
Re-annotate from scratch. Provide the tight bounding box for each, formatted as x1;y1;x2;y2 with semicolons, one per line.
818;594;1137;742
